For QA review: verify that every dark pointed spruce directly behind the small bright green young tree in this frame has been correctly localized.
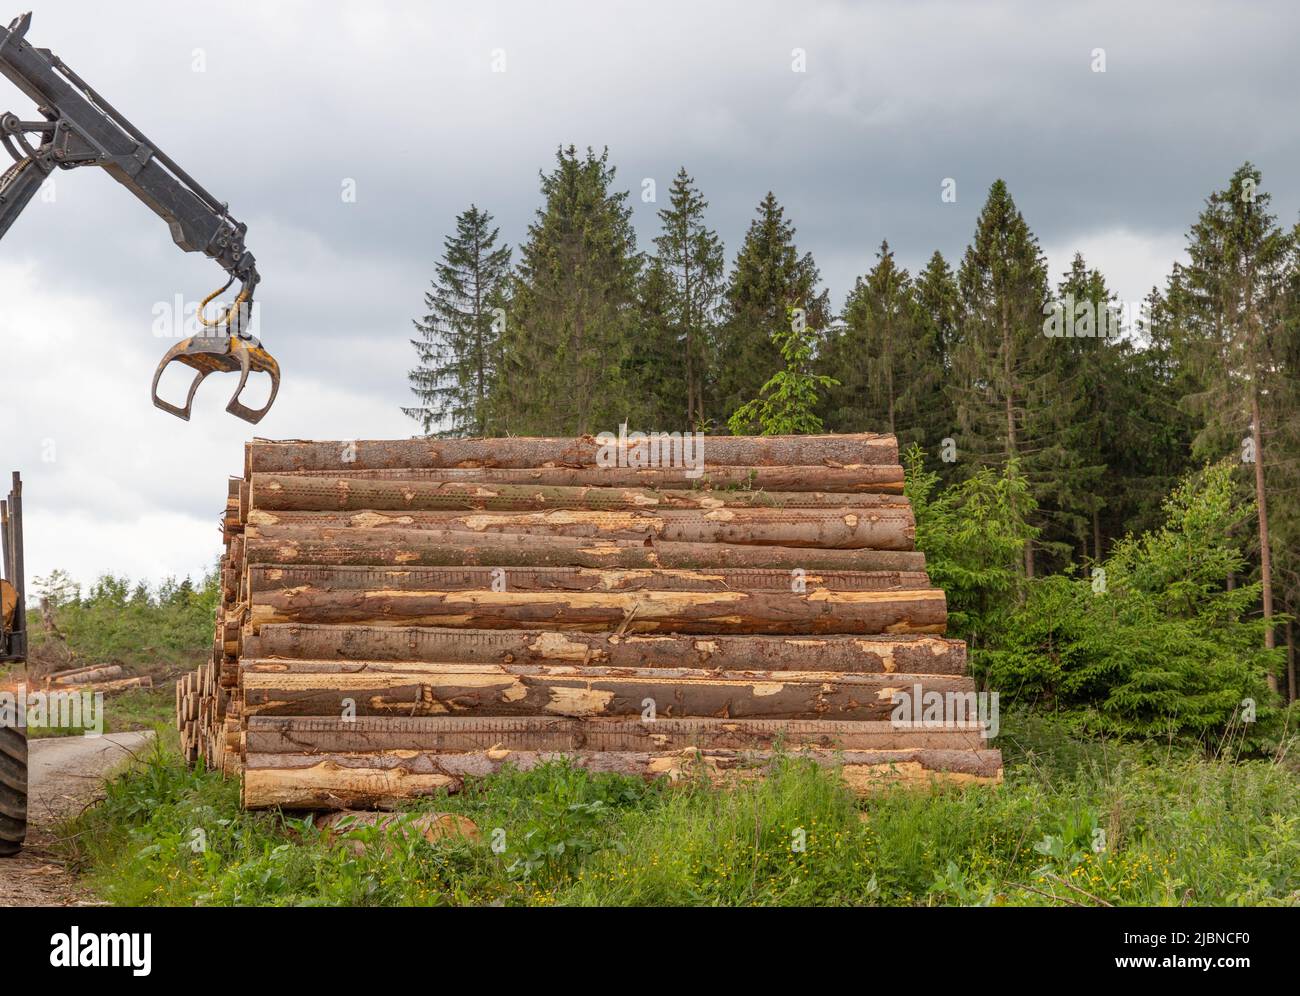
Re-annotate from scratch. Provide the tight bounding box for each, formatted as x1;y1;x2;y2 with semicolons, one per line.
715;192;831;417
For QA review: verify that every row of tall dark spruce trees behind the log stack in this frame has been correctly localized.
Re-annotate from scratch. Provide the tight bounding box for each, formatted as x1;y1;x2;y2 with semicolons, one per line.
404;147;1300;717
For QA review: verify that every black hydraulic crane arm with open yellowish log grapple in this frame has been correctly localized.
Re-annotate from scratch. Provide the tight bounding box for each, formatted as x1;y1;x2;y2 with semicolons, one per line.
0;13;280;423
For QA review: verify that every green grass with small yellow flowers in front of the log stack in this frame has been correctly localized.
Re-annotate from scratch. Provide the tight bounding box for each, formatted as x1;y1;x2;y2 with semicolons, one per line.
60;720;1300;905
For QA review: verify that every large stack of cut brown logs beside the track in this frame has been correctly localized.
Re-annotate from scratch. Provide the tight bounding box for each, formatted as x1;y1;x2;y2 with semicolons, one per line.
177;434;1001;809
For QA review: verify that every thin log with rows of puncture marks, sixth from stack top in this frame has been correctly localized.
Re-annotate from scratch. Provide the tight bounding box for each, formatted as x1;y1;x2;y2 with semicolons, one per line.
248;564;930;598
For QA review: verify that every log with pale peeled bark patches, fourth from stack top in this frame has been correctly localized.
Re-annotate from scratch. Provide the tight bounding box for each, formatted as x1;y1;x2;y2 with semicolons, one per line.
248;508;917;550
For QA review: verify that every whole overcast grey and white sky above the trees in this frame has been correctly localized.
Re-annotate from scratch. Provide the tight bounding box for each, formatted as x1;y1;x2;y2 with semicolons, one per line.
0;0;1300;581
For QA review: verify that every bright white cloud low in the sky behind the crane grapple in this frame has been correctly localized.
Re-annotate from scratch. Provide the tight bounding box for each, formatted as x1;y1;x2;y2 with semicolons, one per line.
0;263;412;581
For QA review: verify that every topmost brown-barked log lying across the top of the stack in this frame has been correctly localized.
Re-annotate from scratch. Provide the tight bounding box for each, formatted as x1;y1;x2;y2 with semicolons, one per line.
244;433;898;478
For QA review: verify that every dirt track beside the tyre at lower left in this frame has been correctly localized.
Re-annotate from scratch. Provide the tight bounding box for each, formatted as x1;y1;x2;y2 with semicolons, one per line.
0;732;153;906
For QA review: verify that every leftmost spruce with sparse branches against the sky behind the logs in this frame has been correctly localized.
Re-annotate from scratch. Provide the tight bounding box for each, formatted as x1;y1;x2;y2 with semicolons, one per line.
402;204;510;436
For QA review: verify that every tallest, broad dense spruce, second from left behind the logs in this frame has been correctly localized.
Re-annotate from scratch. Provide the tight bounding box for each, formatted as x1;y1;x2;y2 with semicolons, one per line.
493;146;641;436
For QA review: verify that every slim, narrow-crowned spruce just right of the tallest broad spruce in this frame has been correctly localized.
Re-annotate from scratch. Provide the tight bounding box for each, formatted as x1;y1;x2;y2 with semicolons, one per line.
654;166;724;429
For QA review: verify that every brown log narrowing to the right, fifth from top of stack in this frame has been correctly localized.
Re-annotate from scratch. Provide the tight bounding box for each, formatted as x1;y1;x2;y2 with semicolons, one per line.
247;525;926;571
